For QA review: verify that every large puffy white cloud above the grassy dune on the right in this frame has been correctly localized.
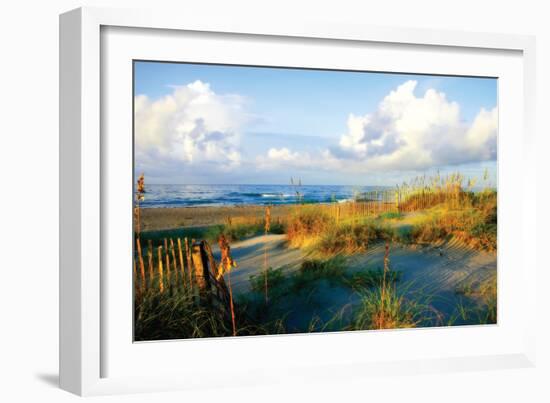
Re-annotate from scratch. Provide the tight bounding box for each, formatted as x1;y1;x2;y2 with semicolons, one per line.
330;80;498;170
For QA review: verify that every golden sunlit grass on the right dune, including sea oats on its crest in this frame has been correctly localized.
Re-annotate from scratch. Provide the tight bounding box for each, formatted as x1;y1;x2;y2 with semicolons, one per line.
286;173;497;255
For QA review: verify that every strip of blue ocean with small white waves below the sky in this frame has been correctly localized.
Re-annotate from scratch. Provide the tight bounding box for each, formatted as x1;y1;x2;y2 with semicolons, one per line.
141;185;390;207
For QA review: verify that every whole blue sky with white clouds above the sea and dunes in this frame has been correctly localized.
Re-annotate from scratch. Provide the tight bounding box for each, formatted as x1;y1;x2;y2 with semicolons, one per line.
134;62;498;185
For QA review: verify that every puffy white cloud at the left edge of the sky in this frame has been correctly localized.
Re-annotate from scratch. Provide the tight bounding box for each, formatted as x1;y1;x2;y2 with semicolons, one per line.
134;81;248;168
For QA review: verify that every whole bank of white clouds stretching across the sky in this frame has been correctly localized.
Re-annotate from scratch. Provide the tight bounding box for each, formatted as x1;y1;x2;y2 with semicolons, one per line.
139;80;498;181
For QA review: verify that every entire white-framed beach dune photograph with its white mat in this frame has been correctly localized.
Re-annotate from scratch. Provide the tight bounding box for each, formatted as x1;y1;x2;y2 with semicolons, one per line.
60;8;536;395
